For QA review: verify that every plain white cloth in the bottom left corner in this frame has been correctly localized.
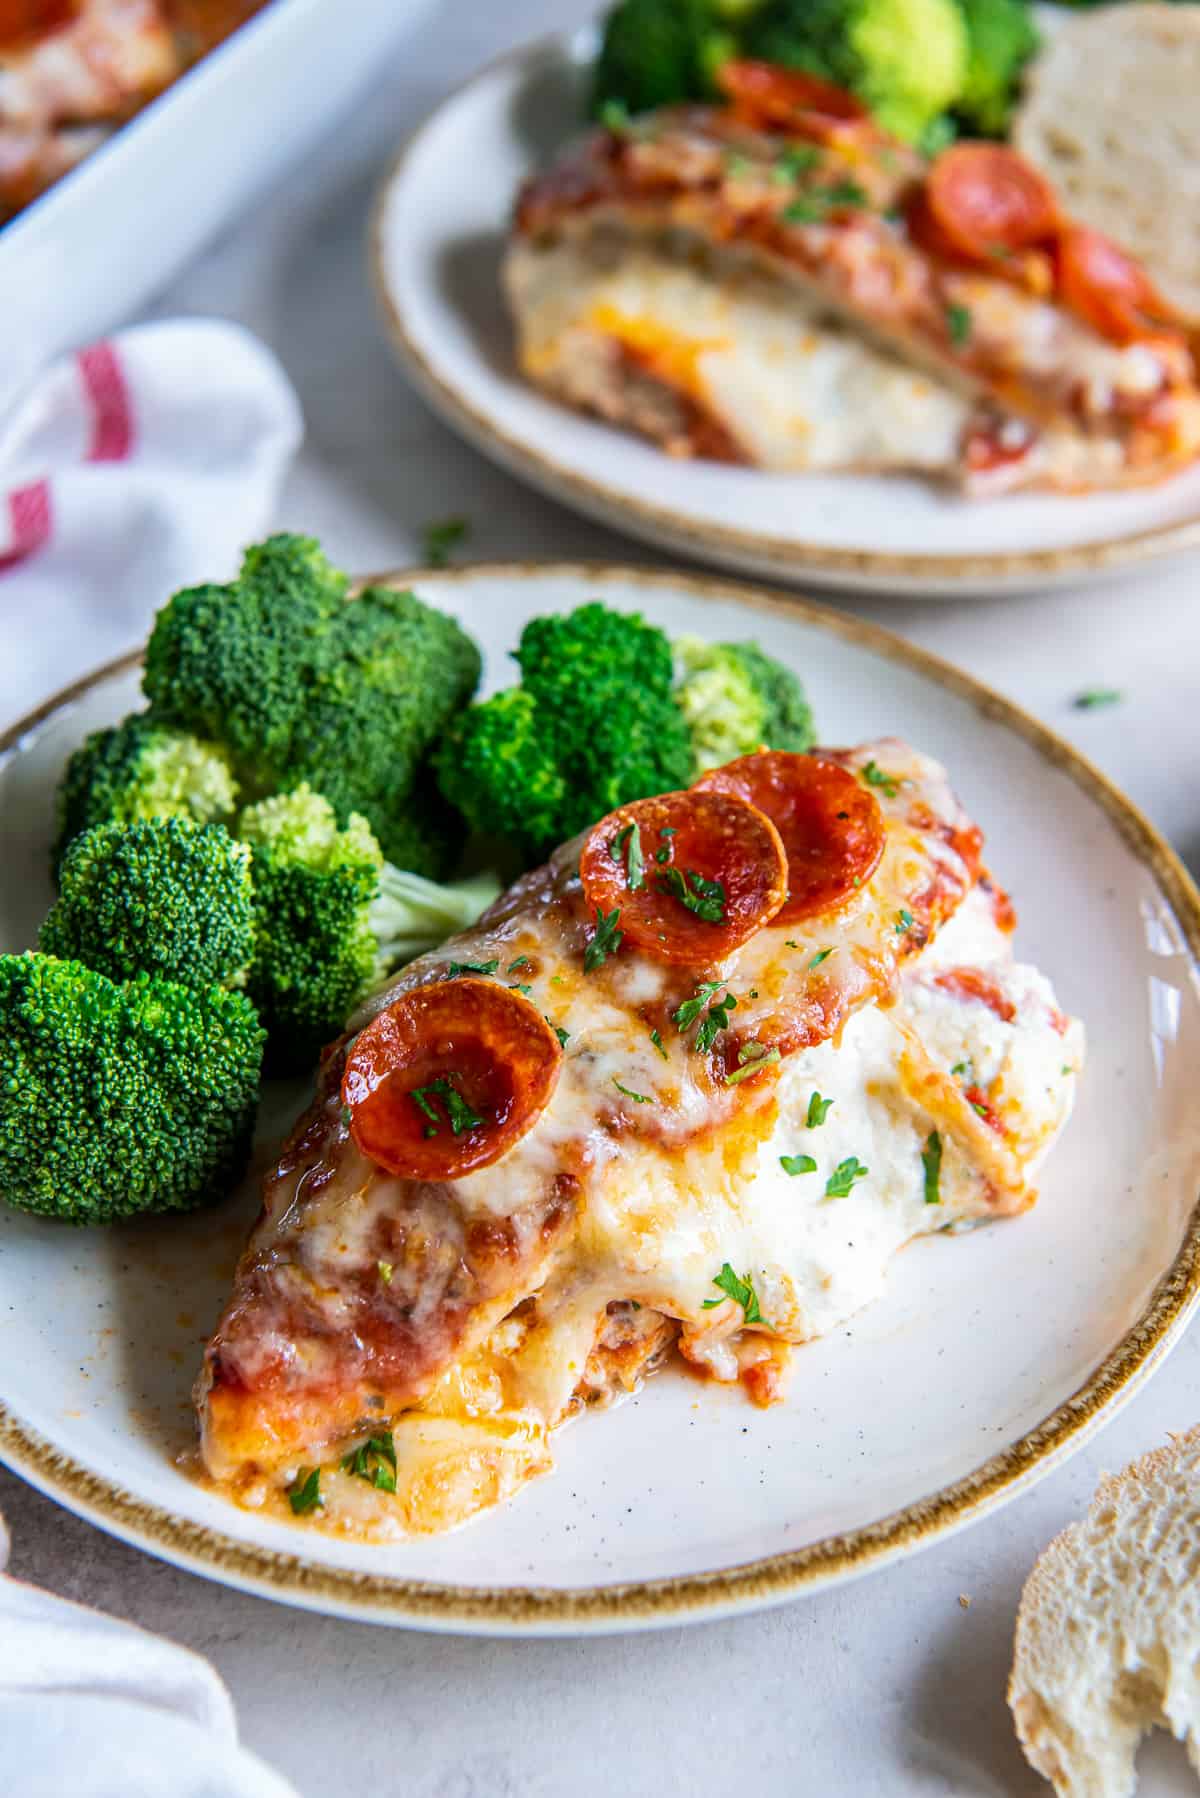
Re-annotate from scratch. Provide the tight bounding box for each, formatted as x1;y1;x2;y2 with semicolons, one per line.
0;1518;297;1798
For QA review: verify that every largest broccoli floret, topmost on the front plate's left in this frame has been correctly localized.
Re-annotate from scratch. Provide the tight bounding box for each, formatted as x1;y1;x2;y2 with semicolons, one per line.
144;536;480;876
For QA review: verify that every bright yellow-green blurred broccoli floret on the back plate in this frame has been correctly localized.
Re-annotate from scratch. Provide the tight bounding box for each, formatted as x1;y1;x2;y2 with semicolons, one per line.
745;0;968;142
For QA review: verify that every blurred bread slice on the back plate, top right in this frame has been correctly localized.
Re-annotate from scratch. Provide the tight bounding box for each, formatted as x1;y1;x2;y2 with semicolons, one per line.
1013;4;1200;316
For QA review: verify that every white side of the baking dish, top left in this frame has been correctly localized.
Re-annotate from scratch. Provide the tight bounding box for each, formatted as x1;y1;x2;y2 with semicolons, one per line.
0;0;432;390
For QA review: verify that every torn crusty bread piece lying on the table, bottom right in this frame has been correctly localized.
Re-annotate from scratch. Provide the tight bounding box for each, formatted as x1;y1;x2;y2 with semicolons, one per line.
1007;1426;1200;1798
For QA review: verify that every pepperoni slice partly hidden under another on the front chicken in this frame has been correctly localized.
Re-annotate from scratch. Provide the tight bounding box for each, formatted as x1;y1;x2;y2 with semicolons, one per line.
693;750;885;924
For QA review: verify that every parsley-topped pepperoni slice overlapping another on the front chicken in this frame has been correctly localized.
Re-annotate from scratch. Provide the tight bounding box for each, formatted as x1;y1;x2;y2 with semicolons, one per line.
579;789;788;967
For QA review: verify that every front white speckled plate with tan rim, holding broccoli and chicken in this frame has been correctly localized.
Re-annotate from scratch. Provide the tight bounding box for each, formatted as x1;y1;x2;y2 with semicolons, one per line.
0;566;1200;1634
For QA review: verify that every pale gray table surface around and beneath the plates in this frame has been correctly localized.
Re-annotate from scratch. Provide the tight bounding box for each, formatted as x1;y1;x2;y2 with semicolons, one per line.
0;0;1200;1798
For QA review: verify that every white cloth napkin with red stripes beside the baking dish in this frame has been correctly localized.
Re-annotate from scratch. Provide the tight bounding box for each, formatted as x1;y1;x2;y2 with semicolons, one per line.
0;318;304;725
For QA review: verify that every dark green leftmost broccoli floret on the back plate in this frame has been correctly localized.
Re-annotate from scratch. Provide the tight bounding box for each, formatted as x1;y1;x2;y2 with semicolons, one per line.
592;0;736;117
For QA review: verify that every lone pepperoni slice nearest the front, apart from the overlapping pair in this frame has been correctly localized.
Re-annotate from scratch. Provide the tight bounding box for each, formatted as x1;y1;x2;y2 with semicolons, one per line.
342;980;563;1179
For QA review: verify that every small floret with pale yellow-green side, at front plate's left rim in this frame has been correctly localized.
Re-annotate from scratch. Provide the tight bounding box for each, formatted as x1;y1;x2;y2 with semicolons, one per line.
54;712;237;868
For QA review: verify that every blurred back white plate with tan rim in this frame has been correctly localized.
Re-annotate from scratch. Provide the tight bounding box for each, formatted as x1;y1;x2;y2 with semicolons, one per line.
371;31;1200;597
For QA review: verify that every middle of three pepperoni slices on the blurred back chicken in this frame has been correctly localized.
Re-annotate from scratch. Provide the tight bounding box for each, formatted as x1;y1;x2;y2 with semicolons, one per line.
914;144;1058;263
